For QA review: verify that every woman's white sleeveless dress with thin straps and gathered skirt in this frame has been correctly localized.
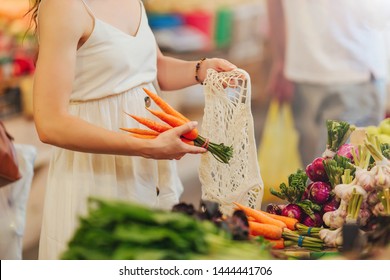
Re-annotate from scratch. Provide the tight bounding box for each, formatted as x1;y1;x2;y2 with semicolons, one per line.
39;1;183;259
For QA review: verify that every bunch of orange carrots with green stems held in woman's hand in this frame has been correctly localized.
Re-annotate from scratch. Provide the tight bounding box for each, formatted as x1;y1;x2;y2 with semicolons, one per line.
121;88;233;163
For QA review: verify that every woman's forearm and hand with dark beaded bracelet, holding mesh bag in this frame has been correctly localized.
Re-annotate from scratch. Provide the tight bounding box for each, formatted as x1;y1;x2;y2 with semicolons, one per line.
157;47;237;90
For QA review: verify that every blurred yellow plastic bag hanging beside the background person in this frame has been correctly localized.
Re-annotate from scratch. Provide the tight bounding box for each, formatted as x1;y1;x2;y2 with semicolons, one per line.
258;100;302;202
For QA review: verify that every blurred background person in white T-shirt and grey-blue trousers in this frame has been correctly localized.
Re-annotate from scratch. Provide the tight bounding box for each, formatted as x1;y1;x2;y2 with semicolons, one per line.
267;0;390;166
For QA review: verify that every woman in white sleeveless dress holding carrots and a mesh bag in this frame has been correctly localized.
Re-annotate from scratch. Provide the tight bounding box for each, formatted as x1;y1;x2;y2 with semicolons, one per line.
33;0;235;259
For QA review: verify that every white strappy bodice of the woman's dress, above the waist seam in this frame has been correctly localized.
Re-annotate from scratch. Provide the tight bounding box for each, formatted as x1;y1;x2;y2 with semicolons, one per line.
70;1;157;101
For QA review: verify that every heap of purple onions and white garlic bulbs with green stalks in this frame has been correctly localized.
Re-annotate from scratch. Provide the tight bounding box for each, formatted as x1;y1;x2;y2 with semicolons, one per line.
258;119;390;256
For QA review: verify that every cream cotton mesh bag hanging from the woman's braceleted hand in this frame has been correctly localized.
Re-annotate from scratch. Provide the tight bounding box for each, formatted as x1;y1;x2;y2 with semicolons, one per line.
199;69;264;215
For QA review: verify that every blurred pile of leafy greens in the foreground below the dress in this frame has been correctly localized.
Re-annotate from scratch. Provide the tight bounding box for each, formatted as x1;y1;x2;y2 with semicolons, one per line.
62;198;271;260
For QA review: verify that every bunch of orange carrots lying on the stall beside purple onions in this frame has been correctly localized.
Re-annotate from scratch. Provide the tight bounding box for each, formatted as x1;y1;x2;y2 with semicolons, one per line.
234;202;324;250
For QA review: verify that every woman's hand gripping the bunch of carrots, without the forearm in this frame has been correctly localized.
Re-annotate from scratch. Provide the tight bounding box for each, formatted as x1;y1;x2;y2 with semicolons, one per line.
147;121;207;160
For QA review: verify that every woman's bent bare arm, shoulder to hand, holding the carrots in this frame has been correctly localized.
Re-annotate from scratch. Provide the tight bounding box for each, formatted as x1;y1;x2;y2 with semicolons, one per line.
34;0;205;159
